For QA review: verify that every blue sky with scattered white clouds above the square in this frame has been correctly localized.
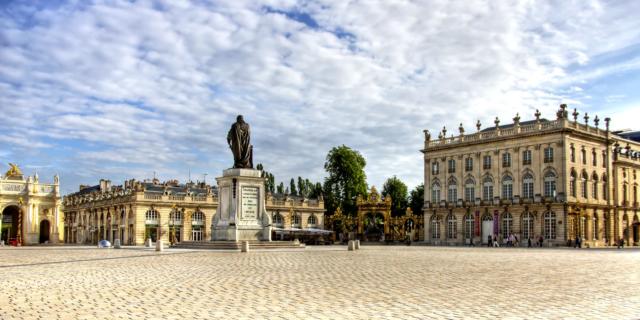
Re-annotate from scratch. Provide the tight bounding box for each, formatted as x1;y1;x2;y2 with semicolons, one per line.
0;0;640;193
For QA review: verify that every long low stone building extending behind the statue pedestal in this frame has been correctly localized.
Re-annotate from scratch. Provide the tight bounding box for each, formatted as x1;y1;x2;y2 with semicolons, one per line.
64;179;324;245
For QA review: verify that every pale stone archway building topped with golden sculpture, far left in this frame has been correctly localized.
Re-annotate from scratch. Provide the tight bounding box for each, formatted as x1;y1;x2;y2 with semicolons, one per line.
0;164;62;245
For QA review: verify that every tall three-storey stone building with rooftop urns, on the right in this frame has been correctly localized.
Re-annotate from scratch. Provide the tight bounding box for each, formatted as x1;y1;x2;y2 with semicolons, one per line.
422;105;640;246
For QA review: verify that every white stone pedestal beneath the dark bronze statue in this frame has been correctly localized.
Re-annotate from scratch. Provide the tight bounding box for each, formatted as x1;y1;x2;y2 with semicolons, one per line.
211;169;271;242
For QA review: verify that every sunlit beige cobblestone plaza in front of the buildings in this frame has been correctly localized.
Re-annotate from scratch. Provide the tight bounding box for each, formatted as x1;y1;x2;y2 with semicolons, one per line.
0;246;640;319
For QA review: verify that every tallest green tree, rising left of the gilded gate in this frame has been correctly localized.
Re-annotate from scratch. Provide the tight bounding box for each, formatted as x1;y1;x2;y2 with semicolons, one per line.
323;145;367;215
